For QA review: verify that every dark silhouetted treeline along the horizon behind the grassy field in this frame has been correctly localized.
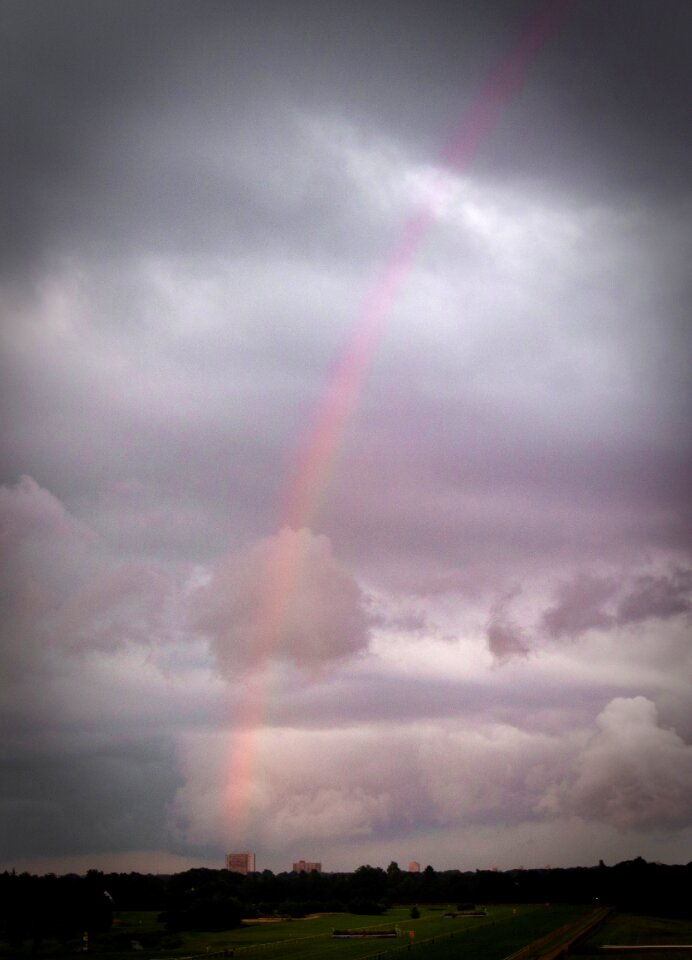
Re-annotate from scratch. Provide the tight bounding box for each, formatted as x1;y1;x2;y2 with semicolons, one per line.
0;857;692;944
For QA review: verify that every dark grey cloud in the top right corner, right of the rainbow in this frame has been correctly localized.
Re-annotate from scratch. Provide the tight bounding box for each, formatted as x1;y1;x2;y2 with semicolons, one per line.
484;0;692;197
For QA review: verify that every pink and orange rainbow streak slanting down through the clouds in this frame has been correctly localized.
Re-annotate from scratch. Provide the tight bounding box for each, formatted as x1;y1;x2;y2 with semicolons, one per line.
226;0;576;843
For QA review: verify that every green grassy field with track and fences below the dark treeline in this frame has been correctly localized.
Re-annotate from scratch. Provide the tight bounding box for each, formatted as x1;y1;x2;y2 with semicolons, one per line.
5;904;692;960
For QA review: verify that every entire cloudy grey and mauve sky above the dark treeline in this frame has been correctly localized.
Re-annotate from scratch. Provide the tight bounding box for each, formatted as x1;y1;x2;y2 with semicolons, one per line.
0;0;692;873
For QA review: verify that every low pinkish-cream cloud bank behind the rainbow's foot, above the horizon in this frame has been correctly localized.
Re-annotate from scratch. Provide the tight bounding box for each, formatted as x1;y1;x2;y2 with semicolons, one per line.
174;720;576;849
